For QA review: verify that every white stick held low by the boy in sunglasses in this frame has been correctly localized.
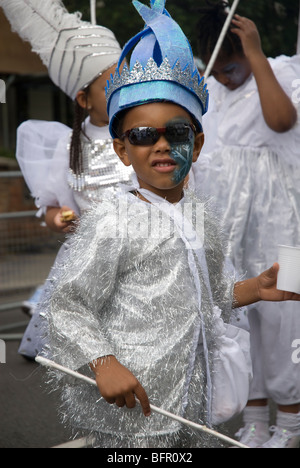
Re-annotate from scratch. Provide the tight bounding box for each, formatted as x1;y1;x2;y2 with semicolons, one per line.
35;356;249;448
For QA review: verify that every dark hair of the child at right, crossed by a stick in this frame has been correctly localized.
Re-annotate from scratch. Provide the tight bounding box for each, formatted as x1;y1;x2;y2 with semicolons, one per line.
196;0;244;63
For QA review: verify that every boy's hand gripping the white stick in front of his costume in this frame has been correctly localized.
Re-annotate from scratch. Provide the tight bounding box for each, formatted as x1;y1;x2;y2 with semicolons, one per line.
91;356;151;416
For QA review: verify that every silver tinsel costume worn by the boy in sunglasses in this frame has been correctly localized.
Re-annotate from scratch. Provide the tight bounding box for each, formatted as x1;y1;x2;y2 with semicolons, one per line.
44;188;249;447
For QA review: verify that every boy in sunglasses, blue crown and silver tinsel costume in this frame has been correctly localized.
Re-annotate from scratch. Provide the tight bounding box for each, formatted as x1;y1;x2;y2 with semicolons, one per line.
42;1;300;448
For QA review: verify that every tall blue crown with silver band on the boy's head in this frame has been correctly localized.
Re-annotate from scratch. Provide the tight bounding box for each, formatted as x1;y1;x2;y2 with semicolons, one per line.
106;0;209;138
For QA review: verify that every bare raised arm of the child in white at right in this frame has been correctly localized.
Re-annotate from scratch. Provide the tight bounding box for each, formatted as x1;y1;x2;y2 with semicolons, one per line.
232;15;297;133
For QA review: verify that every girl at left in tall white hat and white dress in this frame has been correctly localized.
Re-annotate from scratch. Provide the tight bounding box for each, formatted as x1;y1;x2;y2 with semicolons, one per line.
0;0;132;359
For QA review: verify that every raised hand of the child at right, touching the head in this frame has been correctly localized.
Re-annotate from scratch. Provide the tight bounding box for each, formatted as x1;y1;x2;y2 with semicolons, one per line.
231;15;262;59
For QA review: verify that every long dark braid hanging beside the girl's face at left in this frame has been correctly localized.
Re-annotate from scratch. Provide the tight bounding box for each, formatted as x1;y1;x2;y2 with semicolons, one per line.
70;88;89;175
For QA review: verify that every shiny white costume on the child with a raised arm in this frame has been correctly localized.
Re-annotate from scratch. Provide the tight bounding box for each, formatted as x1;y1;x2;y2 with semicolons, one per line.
194;56;300;405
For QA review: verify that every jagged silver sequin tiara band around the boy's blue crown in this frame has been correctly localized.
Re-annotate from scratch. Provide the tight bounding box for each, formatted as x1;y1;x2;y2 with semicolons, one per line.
106;57;208;112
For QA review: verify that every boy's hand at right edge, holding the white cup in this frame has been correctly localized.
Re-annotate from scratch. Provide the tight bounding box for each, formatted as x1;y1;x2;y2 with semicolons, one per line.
257;263;300;302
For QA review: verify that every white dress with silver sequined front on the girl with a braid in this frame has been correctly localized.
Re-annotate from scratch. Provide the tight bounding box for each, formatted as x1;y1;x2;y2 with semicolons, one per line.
17;118;132;358
